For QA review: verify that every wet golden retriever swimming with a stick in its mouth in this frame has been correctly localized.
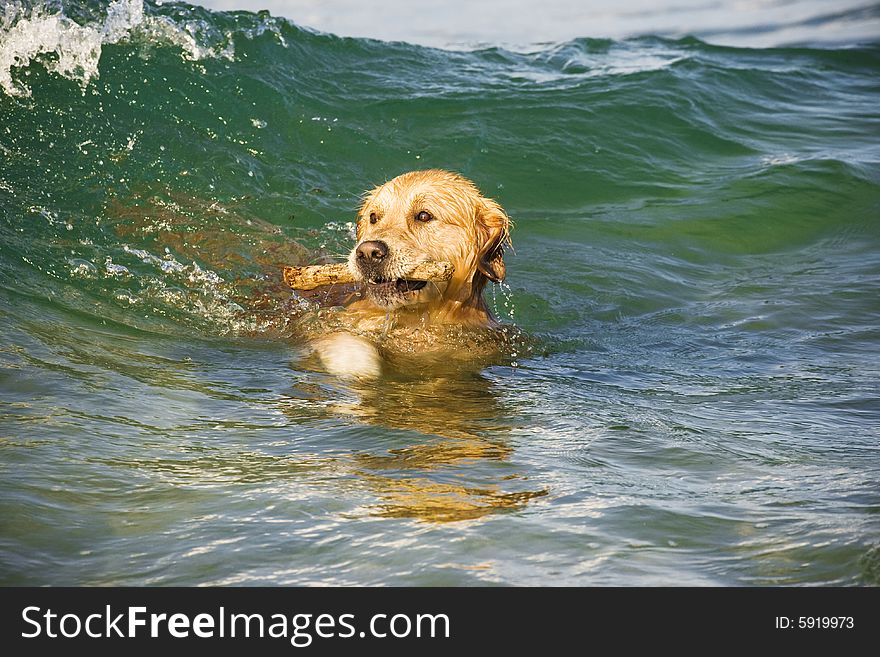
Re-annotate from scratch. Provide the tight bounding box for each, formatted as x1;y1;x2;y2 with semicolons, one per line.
313;169;510;378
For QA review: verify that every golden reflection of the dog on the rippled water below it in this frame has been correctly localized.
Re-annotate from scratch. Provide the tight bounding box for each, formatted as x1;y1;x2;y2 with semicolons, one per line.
285;373;548;522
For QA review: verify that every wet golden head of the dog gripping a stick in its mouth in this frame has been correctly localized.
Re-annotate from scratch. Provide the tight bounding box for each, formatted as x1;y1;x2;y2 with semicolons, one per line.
348;169;510;310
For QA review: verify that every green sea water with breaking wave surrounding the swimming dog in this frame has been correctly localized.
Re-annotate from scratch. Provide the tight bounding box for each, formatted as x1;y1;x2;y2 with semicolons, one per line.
0;2;880;585
